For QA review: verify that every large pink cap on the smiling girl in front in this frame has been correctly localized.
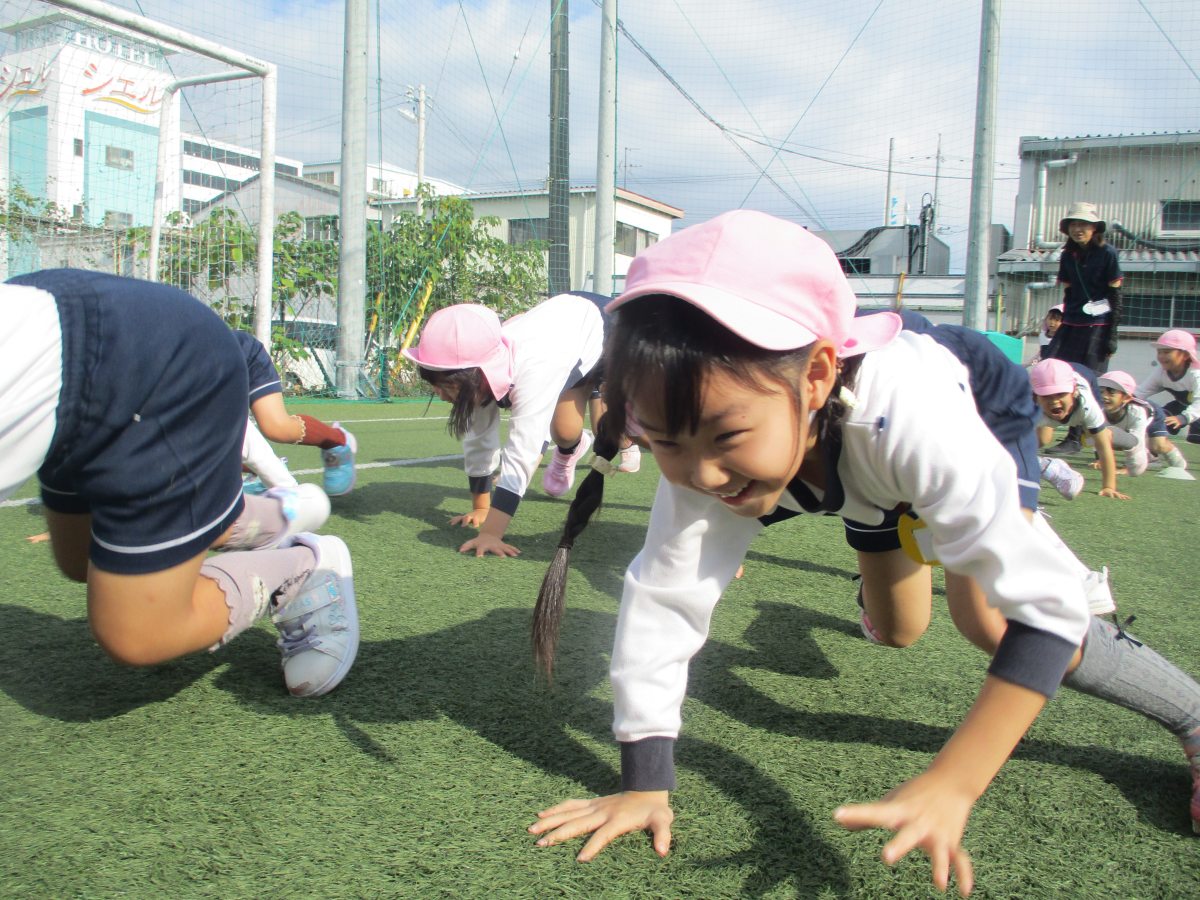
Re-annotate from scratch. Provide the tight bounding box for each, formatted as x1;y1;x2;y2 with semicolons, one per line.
605;210;902;356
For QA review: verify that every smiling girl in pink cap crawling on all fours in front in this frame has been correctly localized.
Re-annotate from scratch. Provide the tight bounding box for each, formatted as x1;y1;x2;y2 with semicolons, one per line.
529;210;1200;894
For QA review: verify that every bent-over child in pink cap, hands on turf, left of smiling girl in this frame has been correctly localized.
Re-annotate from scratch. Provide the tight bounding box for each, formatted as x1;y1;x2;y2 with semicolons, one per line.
404;293;607;557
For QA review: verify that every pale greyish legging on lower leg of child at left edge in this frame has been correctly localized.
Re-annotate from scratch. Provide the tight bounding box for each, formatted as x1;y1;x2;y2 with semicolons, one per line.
200;544;317;650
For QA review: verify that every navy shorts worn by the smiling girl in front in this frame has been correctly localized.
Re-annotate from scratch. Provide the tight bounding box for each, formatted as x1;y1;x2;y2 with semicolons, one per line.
845;310;1041;553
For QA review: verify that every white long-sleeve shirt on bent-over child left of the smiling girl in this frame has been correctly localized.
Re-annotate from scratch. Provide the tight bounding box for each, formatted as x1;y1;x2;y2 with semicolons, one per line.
462;294;604;515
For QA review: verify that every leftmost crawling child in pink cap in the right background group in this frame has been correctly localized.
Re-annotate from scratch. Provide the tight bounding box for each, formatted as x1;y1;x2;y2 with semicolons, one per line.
1030;359;1129;500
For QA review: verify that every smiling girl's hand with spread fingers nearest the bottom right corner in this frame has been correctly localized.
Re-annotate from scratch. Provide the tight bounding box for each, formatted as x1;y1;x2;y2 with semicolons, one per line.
833;773;974;896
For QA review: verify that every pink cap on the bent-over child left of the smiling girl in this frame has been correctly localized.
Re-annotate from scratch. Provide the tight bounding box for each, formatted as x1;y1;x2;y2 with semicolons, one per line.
403;304;512;400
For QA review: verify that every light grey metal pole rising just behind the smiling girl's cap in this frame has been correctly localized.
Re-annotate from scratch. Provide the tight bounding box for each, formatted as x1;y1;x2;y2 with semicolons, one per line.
592;0;617;296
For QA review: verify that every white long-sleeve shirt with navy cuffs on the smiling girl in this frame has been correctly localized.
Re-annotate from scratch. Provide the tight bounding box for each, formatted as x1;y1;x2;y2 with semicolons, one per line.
610;332;1088;790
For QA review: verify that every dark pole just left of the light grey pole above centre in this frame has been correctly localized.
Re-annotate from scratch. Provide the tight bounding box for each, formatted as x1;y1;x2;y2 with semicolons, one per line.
546;0;571;294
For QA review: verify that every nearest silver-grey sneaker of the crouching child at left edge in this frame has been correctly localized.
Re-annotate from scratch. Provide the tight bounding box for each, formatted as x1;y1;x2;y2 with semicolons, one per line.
271;534;359;697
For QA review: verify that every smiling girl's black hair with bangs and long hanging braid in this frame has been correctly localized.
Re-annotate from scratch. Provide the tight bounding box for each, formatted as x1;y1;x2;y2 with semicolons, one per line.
533;295;862;677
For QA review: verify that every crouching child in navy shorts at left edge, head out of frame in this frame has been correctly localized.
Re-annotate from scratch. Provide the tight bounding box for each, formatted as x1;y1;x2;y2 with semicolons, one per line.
0;269;359;696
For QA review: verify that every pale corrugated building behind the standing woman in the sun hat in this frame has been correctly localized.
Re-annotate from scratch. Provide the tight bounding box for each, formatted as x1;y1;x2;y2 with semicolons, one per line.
997;132;1200;343
